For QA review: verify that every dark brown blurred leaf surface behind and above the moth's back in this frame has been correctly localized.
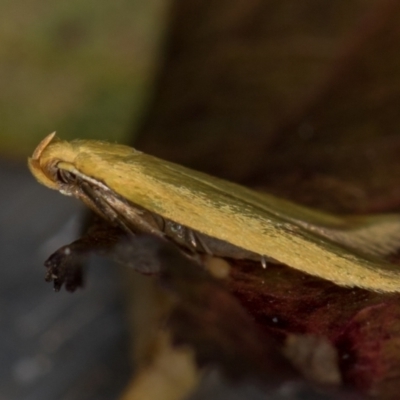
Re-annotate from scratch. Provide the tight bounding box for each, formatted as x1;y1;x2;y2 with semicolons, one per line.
137;0;400;212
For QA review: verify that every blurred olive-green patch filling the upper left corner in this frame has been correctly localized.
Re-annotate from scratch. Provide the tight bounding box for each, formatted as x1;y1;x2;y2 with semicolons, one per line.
0;0;168;157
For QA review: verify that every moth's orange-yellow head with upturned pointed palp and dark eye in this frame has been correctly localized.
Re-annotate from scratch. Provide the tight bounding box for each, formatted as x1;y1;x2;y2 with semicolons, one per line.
28;132;78;195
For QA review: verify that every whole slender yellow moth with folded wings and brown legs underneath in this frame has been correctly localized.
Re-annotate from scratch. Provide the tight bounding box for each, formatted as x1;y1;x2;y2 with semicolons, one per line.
28;133;400;292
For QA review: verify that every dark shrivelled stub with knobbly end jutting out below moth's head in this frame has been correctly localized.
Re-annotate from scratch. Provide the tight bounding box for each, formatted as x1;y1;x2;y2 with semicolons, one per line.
45;216;126;292
